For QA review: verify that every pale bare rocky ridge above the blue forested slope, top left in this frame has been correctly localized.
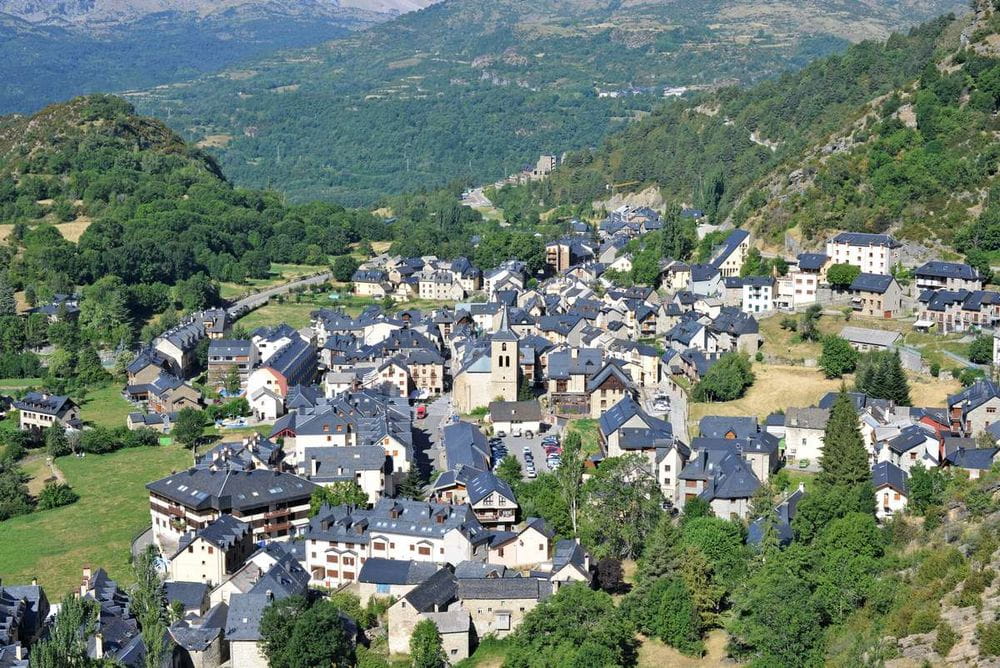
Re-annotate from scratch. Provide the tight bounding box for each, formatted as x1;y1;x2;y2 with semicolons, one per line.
0;0;437;28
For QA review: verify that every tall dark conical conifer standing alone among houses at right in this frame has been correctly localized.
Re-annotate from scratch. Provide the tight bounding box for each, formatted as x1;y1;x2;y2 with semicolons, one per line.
817;387;871;487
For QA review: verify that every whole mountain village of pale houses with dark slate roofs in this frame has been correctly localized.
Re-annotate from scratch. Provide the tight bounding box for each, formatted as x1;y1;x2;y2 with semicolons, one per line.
0;201;1000;668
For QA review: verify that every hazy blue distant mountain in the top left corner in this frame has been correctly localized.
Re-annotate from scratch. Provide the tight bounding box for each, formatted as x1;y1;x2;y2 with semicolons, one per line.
0;0;436;113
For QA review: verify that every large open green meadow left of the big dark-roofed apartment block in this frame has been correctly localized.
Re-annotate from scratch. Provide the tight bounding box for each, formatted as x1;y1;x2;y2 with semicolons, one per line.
0;446;190;601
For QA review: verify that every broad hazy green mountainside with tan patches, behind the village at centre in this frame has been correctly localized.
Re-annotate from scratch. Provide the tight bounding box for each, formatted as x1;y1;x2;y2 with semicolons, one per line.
130;0;964;203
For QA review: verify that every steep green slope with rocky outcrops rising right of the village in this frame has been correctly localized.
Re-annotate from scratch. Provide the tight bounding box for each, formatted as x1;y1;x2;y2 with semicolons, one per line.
498;4;1000;264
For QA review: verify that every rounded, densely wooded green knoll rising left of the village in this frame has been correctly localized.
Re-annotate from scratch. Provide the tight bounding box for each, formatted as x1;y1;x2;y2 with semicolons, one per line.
0;96;384;302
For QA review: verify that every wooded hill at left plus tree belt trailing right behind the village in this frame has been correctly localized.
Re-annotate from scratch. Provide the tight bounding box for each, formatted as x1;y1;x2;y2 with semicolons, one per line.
0;96;540;332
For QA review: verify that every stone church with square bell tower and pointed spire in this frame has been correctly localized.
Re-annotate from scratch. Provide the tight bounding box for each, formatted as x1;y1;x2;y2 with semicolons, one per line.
452;306;520;414
